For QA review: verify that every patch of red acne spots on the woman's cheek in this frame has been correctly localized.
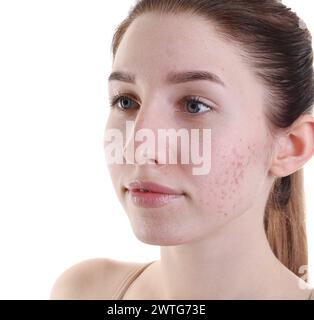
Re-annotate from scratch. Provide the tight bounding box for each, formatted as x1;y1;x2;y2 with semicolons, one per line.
198;144;260;217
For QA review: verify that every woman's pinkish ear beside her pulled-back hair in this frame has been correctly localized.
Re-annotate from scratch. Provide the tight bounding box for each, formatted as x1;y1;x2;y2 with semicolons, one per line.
269;114;314;177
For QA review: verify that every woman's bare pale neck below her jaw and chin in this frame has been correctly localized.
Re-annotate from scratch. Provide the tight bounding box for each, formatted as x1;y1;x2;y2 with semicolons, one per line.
158;209;297;299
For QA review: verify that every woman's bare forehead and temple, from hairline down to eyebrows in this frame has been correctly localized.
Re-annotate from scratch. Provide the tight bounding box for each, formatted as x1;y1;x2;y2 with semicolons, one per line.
112;13;265;110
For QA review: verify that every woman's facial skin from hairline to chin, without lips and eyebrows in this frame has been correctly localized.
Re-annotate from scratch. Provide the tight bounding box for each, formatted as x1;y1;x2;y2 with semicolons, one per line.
106;13;271;245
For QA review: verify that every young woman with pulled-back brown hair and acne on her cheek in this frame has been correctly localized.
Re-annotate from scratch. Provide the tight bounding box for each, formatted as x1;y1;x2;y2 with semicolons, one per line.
51;0;314;299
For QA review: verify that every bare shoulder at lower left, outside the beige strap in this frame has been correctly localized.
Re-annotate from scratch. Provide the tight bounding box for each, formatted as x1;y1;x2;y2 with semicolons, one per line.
50;258;146;300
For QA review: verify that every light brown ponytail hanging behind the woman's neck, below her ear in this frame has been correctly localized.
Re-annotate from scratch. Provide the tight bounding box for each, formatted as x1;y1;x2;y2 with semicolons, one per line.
264;168;308;280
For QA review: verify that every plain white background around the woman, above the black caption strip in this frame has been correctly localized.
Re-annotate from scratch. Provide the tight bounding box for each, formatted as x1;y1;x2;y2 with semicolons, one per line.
0;0;314;299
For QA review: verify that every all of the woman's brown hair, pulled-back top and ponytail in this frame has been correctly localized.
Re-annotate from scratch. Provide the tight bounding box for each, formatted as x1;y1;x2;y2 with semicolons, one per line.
111;0;314;281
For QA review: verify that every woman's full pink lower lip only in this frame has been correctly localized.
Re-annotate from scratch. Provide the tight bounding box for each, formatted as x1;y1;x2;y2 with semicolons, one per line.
126;190;183;208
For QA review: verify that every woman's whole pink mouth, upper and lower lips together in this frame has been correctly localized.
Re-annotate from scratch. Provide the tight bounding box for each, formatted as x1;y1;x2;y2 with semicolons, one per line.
125;180;185;208
